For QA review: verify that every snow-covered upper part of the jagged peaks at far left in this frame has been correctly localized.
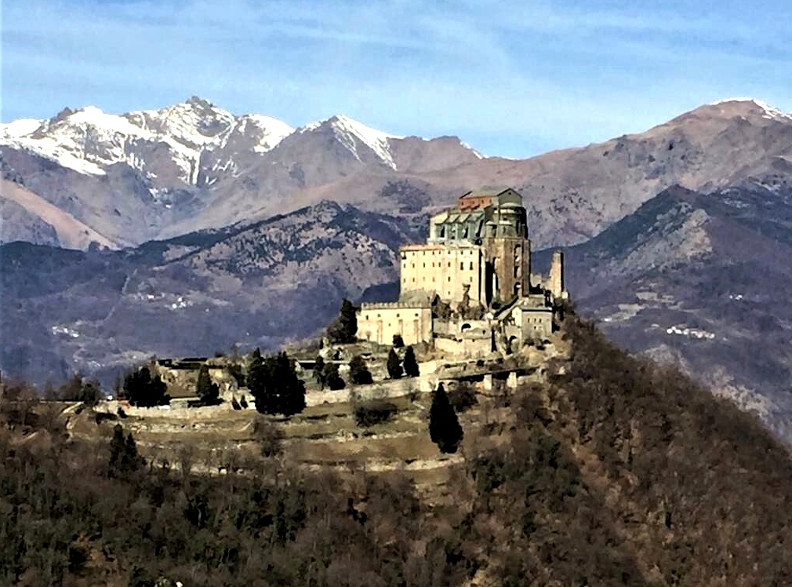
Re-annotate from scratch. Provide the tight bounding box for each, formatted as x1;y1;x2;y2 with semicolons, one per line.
0;97;294;189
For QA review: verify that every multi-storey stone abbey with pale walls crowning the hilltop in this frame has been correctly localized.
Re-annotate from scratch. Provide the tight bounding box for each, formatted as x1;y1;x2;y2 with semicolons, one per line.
357;188;568;358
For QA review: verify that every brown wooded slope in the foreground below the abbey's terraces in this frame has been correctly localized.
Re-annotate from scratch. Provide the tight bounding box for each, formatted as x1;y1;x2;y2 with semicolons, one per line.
0;315;792;587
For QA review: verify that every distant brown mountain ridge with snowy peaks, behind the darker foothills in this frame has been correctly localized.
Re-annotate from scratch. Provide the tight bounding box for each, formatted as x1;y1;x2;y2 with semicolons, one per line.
0;98;792;252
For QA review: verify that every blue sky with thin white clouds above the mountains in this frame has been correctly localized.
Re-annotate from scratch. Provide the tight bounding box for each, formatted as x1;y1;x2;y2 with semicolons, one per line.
0;0;792;157
